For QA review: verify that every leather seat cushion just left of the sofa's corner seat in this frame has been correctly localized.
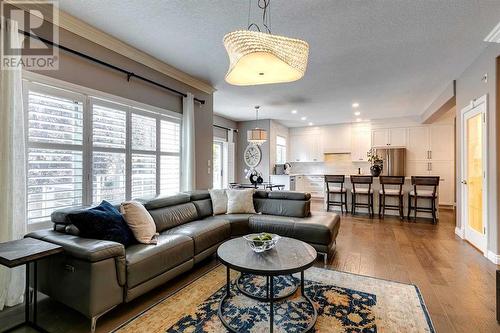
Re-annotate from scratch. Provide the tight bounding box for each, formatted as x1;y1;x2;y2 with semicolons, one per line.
164;218;231;255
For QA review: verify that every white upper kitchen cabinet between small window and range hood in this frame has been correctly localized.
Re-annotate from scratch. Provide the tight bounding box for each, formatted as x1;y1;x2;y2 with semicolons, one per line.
290;130;324;162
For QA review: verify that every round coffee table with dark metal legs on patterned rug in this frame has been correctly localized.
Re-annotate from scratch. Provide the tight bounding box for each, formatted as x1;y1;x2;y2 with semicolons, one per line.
217;237;318;332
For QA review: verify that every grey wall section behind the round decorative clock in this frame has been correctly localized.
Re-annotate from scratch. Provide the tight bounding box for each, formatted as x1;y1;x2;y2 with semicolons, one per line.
236;119;271;183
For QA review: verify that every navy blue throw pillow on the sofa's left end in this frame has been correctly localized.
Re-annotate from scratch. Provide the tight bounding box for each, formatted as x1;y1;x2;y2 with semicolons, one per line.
68;200;135;246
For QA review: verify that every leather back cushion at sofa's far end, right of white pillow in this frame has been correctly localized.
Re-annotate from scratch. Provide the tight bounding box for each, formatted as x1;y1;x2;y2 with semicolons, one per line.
253;196;311;217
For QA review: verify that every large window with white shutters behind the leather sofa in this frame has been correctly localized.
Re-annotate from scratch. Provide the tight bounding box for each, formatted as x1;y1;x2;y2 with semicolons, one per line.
24;82;181;224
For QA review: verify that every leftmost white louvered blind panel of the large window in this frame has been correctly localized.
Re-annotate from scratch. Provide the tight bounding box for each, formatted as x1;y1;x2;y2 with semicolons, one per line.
26;89;83;224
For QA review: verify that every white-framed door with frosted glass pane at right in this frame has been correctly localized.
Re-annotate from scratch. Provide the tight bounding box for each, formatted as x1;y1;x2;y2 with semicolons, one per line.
461;97;487;253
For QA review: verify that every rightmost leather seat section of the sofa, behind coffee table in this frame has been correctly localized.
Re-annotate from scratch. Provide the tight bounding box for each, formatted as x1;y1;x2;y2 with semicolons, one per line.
249;212;340;245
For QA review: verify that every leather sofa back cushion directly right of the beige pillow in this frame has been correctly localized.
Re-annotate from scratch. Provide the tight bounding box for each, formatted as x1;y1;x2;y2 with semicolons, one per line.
146;202;198;232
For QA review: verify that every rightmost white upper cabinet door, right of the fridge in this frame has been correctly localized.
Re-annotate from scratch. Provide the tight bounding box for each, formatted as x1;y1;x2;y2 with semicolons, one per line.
429;124;455;161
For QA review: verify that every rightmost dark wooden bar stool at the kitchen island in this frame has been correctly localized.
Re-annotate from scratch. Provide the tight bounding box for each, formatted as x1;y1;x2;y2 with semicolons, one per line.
408;176;439;224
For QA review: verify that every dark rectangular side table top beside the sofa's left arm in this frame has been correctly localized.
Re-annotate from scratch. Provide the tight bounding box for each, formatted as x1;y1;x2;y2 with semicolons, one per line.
0;237;63;268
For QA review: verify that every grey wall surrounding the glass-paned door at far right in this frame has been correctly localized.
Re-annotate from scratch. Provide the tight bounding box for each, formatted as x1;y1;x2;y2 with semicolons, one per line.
456;44;500;254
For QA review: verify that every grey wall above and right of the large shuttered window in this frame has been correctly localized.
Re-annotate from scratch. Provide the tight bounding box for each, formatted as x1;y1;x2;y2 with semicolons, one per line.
24;18;213;188
